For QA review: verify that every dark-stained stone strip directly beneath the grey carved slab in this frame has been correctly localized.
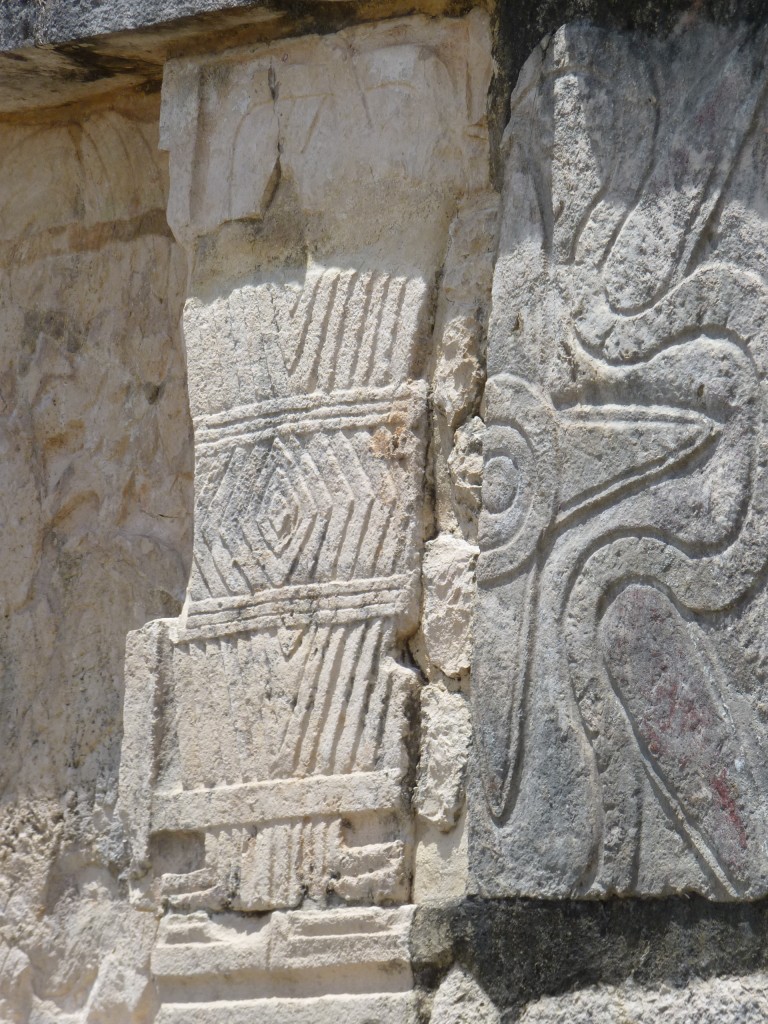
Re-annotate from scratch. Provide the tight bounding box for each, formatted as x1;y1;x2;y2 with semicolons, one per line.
411;897;768;1024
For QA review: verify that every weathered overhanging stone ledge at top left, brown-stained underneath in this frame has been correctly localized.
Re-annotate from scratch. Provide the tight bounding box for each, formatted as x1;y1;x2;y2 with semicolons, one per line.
0;0;483;116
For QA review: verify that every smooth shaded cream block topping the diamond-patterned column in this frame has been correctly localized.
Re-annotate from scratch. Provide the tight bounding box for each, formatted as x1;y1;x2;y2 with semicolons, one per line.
161;11;490;247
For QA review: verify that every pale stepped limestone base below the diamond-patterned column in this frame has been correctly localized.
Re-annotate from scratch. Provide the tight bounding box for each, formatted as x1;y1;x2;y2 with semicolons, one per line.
152;907;418;1024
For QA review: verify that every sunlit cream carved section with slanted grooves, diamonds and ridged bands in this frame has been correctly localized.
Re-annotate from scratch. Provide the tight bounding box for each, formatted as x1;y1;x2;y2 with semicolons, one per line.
120;245;434;912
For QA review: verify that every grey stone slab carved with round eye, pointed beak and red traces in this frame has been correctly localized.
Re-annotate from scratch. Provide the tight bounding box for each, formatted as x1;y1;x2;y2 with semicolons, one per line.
470;25;768;899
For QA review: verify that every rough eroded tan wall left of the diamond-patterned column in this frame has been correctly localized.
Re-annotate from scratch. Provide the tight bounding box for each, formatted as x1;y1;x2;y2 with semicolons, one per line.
0;95;191;1024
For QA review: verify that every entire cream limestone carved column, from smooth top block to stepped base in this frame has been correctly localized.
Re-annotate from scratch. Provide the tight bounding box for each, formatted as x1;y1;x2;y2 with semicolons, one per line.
121;12;489;1022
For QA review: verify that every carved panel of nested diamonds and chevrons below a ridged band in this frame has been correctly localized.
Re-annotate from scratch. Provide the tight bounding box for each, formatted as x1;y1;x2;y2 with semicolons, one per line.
190;386;424;601
